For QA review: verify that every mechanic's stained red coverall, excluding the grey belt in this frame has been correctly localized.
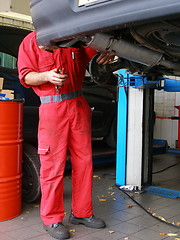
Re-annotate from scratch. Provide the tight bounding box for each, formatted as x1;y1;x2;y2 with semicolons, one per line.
18;32;97;225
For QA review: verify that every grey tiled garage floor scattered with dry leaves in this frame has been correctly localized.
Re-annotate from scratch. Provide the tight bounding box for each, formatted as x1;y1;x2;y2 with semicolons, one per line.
0;154;180;240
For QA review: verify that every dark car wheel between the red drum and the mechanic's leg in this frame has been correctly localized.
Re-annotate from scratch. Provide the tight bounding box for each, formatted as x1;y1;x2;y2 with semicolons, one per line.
22;144;41;202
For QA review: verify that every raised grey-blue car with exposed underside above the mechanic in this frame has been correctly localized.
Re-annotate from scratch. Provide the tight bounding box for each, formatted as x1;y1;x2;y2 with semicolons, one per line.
31;0;180;77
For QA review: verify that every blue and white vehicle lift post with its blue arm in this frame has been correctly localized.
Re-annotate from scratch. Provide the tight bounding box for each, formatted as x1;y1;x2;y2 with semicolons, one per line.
116;69;180;194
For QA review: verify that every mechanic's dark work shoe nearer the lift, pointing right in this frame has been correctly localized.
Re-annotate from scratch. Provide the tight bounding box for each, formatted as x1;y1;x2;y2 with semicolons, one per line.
69;213;106;228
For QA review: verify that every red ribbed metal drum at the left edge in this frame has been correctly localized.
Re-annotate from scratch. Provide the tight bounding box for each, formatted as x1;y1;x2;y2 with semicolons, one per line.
0;101;23;221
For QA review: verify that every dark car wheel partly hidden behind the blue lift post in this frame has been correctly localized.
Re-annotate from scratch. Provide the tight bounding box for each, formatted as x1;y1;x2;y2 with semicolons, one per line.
105;118;117;149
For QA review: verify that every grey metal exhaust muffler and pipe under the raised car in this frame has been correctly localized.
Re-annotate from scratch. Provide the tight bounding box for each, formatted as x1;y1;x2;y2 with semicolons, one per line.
81;33;180;72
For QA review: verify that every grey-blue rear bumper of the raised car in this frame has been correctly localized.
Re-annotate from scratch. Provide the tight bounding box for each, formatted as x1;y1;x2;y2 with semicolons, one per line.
31;0;180;46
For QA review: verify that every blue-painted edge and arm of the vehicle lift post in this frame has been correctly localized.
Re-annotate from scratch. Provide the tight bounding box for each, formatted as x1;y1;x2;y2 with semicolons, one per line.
116;69;180;186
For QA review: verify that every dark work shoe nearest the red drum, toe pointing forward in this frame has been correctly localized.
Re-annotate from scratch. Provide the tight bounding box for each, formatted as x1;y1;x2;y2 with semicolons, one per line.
44;222;70;239
